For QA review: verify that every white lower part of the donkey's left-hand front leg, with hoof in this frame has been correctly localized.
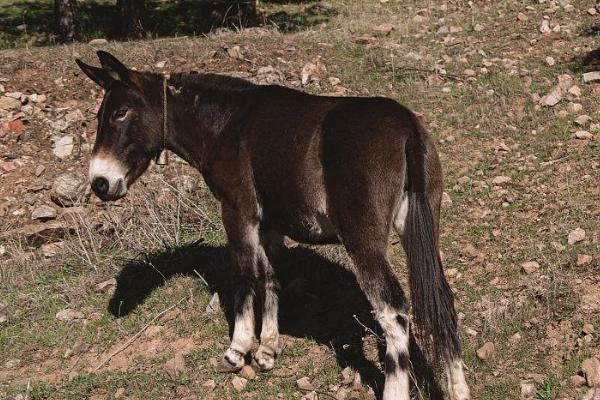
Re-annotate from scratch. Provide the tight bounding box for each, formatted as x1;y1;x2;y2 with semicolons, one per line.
223;295;254;368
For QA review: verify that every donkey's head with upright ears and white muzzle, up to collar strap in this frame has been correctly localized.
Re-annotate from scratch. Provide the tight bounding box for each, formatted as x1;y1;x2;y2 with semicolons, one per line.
76;51;164;200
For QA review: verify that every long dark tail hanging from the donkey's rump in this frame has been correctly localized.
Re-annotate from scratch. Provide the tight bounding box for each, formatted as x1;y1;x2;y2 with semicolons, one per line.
404;115;460;360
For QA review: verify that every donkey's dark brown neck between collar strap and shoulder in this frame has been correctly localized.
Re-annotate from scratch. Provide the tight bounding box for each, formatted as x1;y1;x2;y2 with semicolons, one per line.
165;86;247;172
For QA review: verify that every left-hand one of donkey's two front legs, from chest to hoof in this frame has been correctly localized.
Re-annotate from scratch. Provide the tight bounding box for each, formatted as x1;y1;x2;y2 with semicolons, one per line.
222;205;260;370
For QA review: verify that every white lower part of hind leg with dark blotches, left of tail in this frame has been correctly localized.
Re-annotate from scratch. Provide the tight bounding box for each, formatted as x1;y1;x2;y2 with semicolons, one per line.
376;306;410;400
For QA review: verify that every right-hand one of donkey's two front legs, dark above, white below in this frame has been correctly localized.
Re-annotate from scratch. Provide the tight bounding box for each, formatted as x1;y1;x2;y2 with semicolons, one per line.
254;231;283;371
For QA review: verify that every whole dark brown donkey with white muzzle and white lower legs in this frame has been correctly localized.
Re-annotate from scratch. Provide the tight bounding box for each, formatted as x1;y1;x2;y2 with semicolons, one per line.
77;51;470;400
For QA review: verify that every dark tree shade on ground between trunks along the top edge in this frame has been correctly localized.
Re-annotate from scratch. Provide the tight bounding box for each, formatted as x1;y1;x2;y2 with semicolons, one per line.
0;0;337;48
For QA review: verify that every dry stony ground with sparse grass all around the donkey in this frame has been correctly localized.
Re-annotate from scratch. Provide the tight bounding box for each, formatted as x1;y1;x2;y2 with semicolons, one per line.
0;0;600;400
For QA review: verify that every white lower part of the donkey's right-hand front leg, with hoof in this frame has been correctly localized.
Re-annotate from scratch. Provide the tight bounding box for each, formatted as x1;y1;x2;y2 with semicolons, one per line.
255;283;279;371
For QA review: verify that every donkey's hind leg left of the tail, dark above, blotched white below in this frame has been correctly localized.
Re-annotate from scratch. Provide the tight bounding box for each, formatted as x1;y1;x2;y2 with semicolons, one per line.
347;242;410;400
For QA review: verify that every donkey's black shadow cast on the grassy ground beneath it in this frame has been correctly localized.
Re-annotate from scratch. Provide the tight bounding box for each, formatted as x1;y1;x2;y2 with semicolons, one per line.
108;244;443;399
